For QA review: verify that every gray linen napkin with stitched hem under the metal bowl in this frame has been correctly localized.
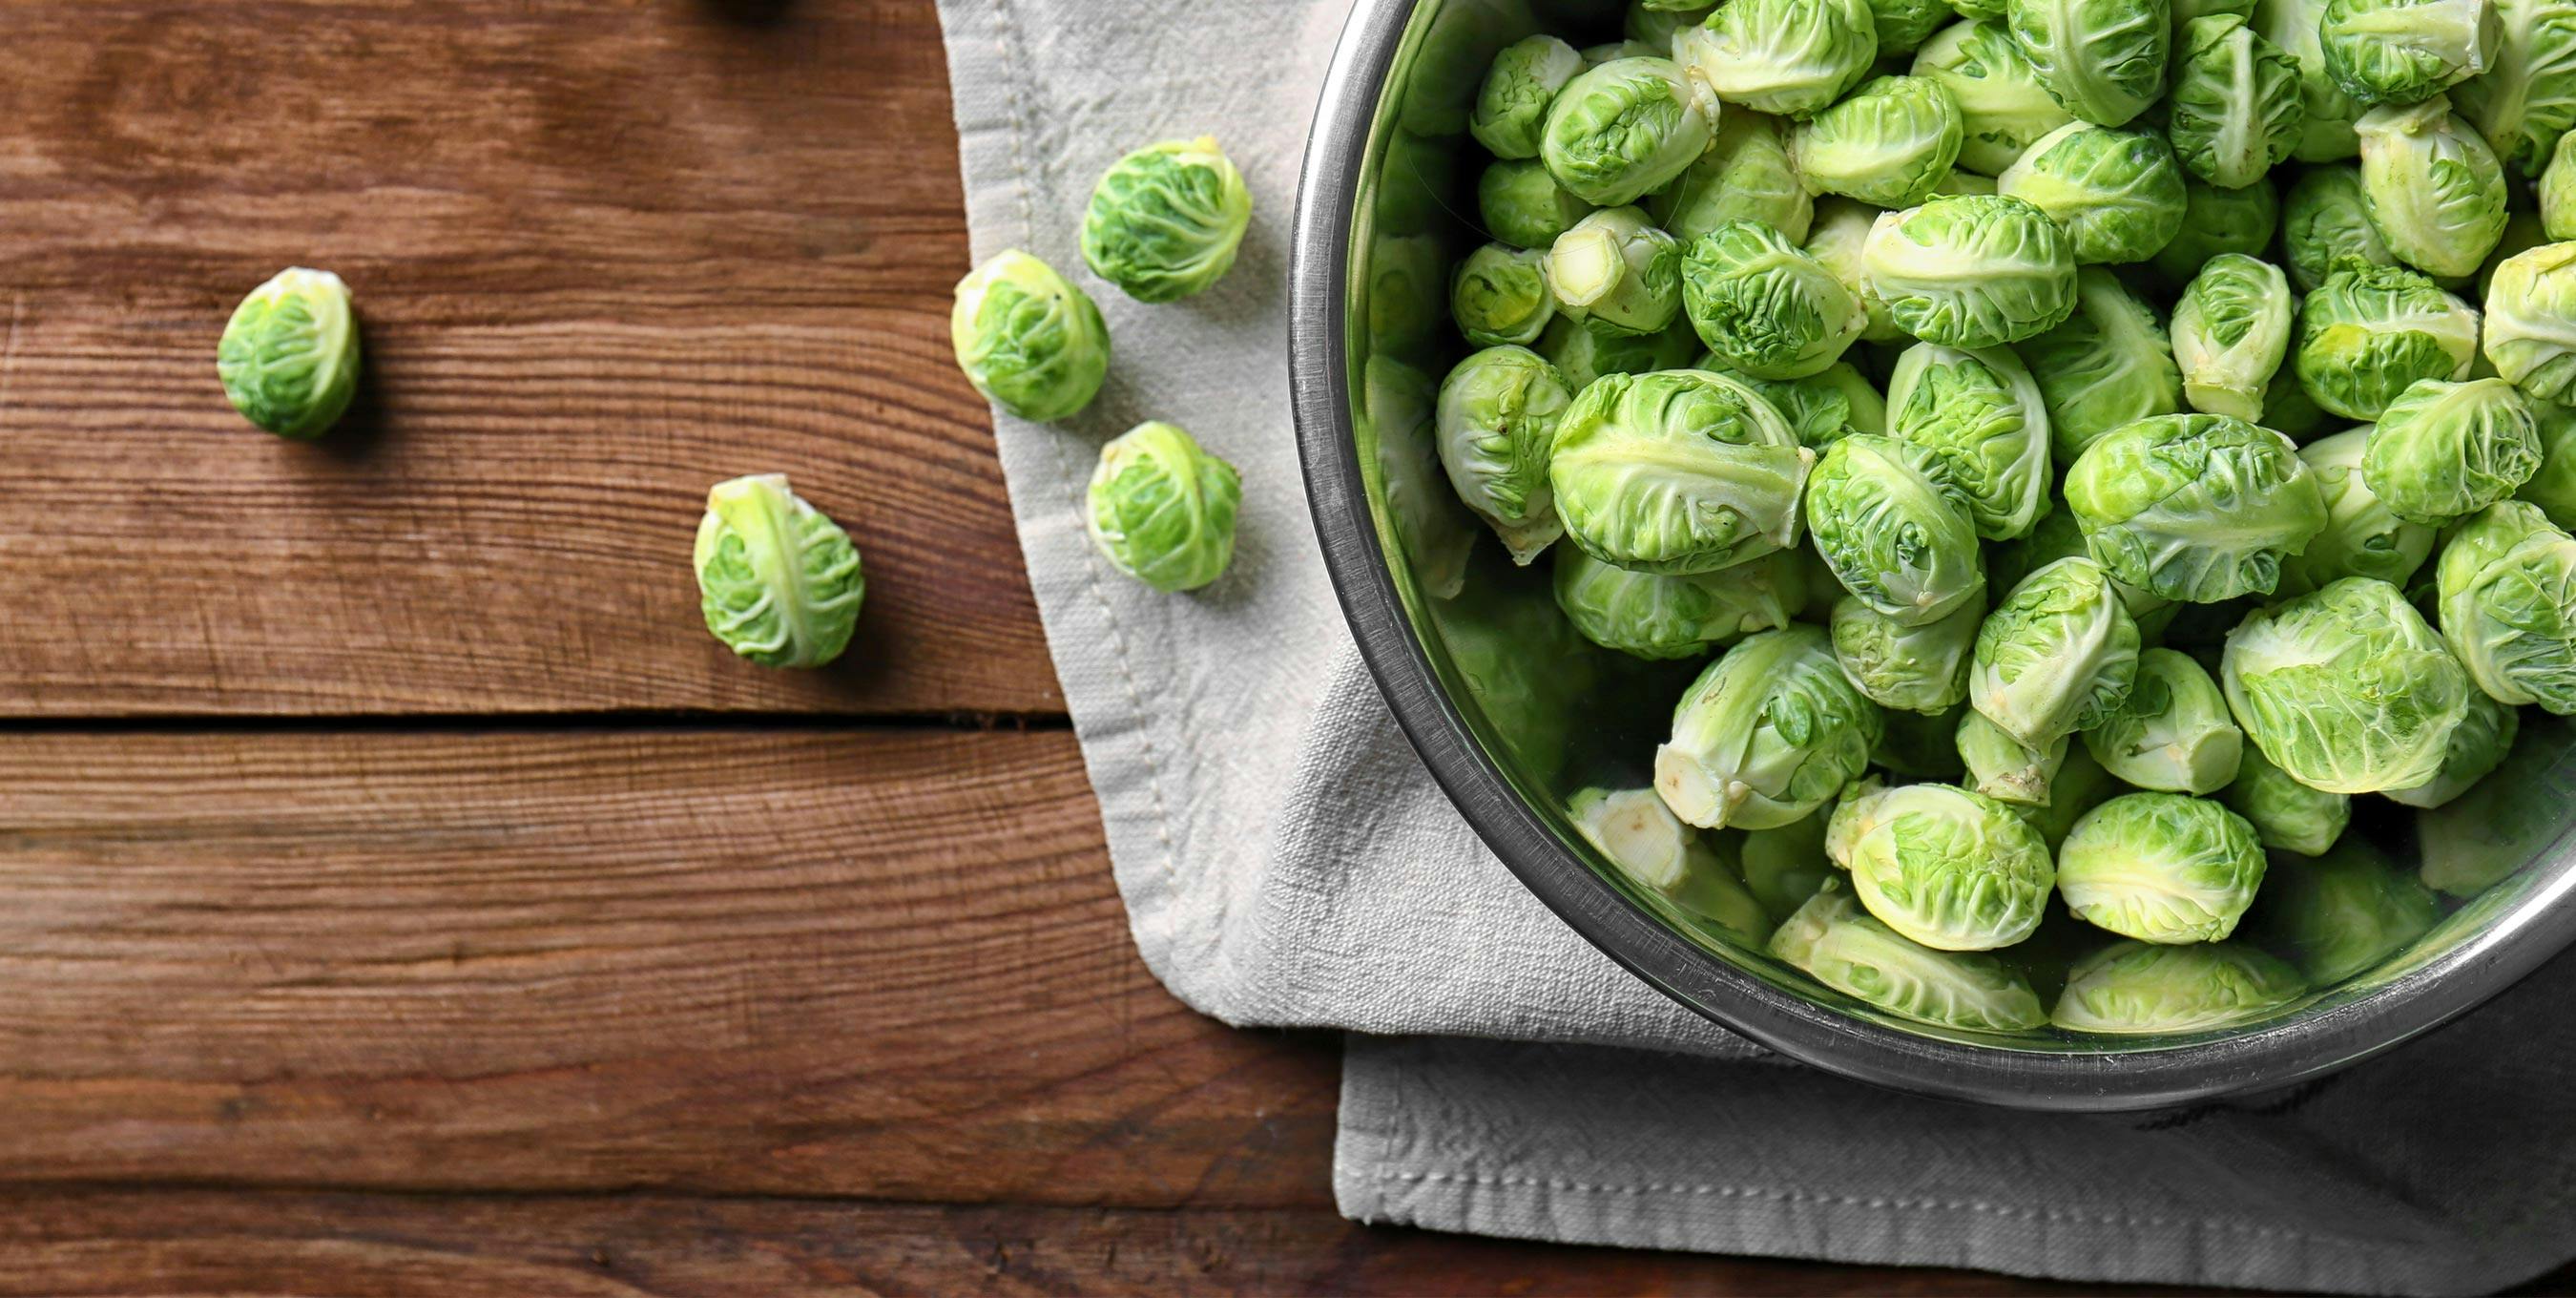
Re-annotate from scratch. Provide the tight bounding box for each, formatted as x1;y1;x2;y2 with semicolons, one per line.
941;0;2576;1293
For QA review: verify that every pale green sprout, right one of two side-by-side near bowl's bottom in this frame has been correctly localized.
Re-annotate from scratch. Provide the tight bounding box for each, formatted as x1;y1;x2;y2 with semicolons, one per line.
2058;787;2264;945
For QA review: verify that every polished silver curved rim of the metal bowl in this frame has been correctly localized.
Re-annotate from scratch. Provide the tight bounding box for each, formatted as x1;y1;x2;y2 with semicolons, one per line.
1288;0;2576;1113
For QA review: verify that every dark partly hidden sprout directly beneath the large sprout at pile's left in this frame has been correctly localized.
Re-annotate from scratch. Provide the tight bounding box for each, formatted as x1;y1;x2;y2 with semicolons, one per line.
1556;546;1808;659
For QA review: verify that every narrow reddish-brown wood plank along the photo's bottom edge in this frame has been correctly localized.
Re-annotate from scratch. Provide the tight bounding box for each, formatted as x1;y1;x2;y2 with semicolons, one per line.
0;1190;2235;1298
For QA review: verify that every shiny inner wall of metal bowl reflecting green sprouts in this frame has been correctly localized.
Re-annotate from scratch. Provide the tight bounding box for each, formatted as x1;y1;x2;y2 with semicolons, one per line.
1301;0;2576;1086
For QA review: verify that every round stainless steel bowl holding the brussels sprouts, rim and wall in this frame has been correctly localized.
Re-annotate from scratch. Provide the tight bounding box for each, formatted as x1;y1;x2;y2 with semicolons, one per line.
1291;0;2576;1110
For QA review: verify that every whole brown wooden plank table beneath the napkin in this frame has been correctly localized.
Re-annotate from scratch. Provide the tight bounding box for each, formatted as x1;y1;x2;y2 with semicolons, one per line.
0;0;2555;1295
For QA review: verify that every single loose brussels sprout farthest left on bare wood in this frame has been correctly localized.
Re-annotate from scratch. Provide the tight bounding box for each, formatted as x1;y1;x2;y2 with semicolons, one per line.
214;265;358;440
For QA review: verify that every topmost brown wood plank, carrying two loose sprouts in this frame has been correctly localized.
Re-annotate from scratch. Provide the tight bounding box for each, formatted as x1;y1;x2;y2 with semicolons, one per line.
0;0;1061;716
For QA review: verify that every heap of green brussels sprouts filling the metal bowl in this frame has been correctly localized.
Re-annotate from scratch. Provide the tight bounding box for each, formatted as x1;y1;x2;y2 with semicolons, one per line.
1435;0;2576;1033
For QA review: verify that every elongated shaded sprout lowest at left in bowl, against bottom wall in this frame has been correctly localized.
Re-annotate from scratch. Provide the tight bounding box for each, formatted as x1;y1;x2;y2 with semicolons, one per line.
1770;884;2048;1033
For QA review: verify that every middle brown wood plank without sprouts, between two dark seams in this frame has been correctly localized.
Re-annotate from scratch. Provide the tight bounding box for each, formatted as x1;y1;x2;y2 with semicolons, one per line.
0;729;1340;1208
